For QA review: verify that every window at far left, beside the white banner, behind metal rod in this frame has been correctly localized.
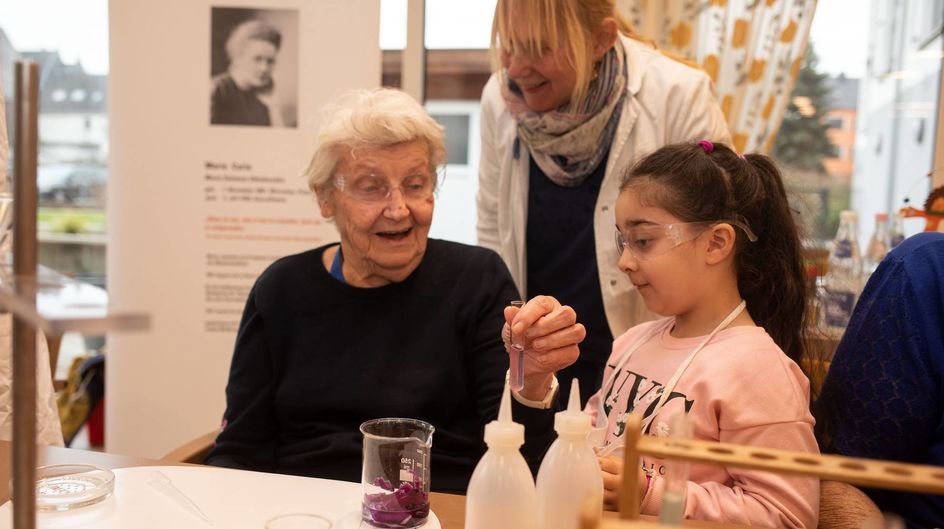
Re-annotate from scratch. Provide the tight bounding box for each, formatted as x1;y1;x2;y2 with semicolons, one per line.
0;0;108;390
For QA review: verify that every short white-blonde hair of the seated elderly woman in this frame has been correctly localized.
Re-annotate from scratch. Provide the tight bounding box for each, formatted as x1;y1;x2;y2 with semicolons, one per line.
305;88;446;196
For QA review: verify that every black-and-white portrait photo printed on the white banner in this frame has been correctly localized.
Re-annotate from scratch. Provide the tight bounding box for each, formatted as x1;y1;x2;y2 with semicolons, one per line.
210;7;298;127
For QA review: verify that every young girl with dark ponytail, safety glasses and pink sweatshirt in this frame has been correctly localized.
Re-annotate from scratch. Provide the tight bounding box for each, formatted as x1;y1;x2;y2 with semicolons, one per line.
587;140;819;528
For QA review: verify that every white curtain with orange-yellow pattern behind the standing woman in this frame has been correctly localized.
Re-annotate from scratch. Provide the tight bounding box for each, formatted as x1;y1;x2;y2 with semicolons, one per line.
617;0;816;153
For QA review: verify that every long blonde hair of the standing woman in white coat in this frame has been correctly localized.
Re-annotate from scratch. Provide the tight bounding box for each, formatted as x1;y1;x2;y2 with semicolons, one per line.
491;0;698;108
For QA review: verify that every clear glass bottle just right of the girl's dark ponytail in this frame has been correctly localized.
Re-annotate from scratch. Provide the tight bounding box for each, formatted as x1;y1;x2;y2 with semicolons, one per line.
822;211;862;336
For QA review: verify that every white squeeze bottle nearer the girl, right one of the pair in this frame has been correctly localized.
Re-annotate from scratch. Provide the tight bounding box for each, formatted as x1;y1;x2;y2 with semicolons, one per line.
537;378;603;529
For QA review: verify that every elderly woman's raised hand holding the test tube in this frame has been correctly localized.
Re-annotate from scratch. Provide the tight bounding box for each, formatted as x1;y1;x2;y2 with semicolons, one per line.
502;296;587;400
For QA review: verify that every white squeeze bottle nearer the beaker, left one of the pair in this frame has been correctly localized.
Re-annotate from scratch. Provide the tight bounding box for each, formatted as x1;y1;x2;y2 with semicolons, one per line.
465;383;538;529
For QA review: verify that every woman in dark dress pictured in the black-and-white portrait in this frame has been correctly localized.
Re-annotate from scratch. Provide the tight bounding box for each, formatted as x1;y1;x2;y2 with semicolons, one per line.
210;19;285;127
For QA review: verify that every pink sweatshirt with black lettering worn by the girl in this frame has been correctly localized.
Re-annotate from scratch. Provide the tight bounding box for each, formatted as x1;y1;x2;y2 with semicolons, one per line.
587;320;819;529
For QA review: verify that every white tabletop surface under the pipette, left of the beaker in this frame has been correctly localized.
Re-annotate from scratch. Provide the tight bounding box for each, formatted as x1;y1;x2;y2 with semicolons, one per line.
0;466;441;529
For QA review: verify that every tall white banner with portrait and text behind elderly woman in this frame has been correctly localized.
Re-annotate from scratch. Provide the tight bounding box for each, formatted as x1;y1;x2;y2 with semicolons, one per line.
105;0;381;457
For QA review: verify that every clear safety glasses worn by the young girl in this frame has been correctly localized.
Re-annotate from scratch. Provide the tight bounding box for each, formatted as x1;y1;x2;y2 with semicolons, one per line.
616;220;757;261
